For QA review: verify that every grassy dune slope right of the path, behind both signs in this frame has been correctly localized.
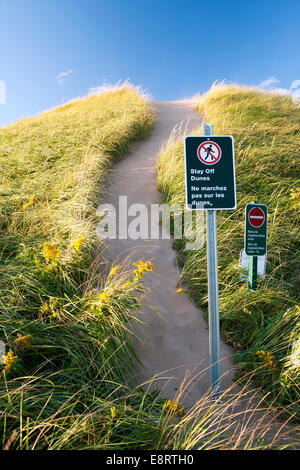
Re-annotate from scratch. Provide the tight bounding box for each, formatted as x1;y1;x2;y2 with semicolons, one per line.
158;86;300;413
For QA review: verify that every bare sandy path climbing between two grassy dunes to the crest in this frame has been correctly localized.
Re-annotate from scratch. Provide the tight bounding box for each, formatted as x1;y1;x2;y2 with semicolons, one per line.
102;101;233;407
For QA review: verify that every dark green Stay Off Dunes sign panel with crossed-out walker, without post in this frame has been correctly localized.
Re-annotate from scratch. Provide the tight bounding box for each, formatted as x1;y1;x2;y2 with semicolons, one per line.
184;135;236;210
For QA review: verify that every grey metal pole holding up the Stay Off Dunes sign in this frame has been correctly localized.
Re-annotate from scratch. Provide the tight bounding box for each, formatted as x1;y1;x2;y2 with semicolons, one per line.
203;124;220;398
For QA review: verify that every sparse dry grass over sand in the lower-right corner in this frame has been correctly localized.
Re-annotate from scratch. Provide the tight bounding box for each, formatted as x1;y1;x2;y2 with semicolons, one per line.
162;374;299;450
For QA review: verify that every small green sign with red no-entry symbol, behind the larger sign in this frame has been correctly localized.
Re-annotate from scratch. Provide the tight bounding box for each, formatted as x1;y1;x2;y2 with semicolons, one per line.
245;203;268;256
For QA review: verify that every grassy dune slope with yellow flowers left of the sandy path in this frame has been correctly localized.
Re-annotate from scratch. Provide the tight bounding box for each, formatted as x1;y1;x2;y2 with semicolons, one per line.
0;87;173;449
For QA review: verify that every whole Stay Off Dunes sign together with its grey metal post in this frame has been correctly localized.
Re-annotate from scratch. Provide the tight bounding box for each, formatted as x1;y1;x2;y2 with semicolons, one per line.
184;124;236;398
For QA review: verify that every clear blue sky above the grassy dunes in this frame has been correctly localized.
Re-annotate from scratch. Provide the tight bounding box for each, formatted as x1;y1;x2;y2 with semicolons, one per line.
0;0;300;126
